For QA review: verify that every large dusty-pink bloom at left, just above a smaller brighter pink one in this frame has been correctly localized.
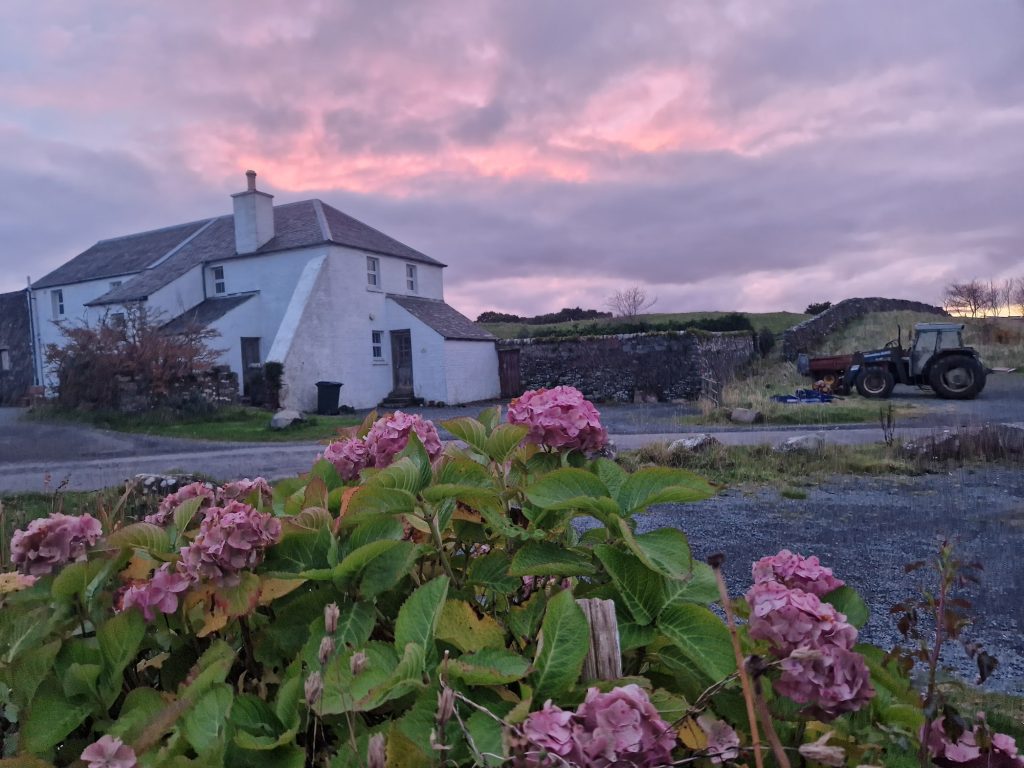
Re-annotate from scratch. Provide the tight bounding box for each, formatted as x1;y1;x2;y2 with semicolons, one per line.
179;502;281;587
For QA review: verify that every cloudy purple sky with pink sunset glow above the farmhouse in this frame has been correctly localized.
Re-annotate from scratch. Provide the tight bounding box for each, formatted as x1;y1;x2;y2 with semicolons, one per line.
0;0;1024;316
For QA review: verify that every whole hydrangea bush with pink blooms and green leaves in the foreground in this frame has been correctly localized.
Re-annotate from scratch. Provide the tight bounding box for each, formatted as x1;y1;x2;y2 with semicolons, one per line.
0;397;1017;768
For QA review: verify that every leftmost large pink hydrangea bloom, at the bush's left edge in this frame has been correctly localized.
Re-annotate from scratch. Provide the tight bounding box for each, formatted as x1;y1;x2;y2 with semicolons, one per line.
10;512;103;575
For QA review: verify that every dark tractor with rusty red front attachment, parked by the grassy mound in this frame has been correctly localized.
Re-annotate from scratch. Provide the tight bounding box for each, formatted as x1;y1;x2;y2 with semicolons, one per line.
797;323;988;400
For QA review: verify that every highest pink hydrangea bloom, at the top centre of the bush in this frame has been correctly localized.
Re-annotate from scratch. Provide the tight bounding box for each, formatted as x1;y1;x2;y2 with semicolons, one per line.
508;386;608;453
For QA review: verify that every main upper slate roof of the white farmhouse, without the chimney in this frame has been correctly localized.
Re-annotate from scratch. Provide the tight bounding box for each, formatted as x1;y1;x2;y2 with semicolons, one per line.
33;200;444;305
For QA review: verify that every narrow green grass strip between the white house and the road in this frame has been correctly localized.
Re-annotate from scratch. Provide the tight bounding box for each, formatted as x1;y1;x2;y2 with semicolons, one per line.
28;407;362;442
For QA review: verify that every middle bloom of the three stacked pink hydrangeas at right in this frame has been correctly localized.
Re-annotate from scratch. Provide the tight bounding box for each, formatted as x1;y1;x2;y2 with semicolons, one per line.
746;582;857;656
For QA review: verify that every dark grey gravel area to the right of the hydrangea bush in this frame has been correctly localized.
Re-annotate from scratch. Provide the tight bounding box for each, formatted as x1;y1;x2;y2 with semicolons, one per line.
640;467;1024;695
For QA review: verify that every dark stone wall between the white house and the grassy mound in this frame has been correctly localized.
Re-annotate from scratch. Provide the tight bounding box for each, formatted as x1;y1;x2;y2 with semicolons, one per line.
499;331;755;402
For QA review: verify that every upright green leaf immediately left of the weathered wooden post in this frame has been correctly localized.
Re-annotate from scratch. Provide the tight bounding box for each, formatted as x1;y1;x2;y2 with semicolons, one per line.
532;591;590;701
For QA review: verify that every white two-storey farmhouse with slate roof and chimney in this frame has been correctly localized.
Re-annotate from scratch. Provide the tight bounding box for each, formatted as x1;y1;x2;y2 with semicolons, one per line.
31;171;500;411
